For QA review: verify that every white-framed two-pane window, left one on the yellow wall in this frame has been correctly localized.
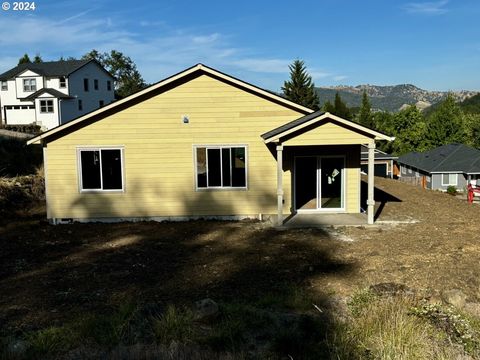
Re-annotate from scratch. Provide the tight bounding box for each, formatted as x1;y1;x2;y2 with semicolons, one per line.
78;148;124;191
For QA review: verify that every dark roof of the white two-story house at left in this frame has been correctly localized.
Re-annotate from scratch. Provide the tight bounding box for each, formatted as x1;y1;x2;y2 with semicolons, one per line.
0;59;111;81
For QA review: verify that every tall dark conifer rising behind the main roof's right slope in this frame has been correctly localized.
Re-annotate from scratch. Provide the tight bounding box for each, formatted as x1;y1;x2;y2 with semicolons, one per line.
282;60;319;110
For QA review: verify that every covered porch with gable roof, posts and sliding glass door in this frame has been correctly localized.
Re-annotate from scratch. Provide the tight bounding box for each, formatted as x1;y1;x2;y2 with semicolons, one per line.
262;112;393;226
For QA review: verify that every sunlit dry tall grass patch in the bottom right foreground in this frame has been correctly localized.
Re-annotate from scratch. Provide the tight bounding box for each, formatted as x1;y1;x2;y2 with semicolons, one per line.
329;291;458;360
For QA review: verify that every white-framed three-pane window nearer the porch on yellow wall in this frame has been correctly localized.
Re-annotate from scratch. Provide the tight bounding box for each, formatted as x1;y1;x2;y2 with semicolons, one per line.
195;146;247;189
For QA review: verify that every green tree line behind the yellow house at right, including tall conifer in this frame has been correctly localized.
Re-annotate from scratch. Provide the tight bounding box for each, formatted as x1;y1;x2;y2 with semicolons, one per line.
282;60;480;155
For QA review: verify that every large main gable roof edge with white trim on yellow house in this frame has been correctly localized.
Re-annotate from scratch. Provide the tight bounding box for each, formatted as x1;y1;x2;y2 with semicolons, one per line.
27;64;313;145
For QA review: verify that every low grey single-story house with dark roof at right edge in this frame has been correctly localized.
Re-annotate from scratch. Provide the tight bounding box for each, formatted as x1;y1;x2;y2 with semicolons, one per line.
398;144;480;191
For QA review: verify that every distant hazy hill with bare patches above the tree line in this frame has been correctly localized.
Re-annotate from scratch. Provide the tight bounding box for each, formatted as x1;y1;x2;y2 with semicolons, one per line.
315;84;478;111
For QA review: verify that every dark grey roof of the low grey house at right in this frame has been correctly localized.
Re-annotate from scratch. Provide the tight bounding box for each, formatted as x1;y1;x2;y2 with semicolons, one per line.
398;144;480;174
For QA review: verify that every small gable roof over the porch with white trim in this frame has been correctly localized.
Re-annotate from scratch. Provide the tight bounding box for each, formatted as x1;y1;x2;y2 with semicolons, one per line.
262;111;395;143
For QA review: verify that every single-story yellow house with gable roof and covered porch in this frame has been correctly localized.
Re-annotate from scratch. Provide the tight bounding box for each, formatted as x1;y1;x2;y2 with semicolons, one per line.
28;64;392;224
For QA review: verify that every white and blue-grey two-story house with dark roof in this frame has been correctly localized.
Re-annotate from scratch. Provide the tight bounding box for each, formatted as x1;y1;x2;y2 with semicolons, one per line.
0;60;115;130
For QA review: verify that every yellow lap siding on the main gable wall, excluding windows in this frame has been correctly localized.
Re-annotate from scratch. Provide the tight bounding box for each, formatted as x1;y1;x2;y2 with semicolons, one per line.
47;76;302;218
